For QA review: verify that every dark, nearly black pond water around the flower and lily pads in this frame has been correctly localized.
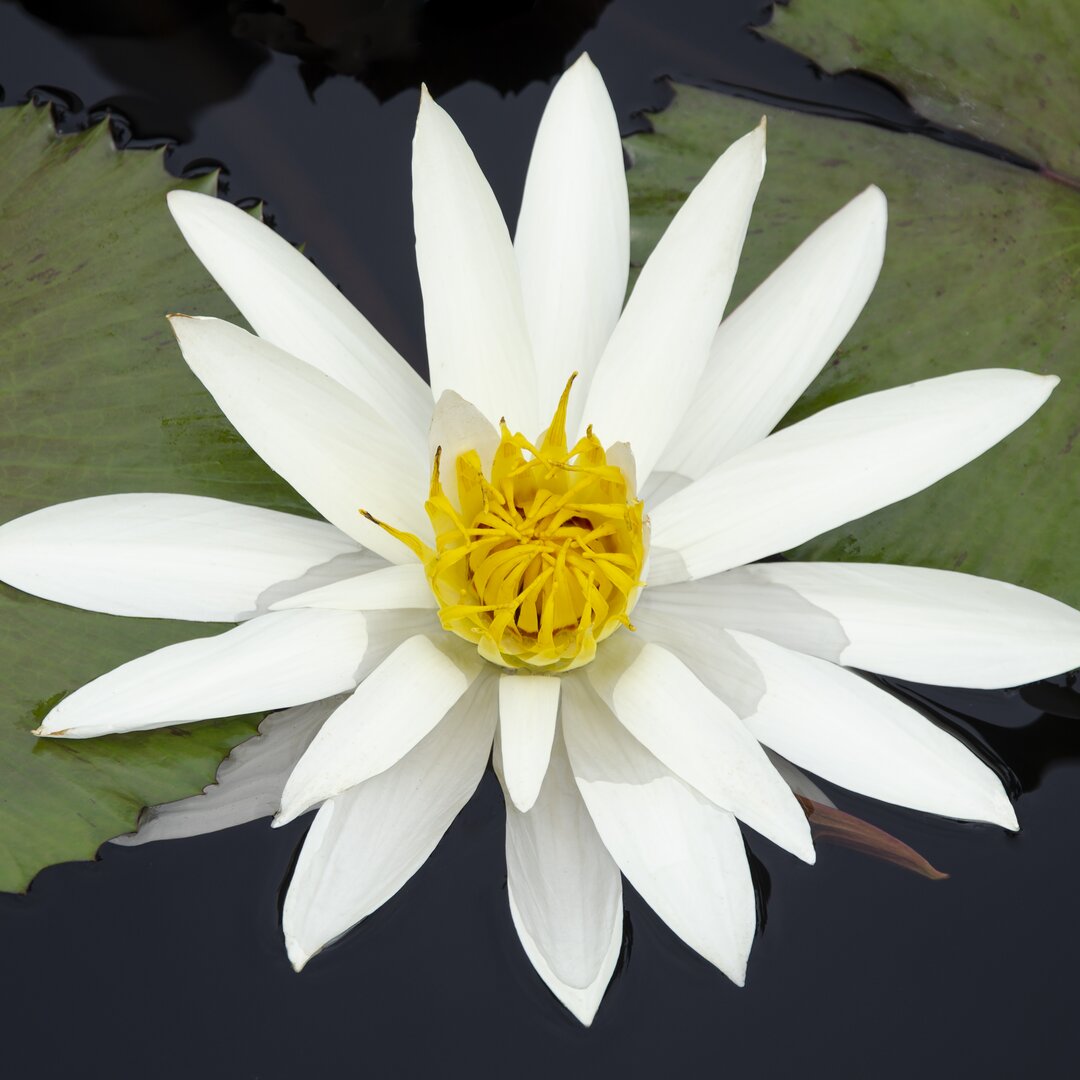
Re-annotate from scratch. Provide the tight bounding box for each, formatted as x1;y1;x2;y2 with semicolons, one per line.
0;0;1080;1080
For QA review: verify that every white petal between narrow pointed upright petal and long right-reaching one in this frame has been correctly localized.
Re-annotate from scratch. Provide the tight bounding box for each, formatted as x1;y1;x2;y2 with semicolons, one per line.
659;187;888;478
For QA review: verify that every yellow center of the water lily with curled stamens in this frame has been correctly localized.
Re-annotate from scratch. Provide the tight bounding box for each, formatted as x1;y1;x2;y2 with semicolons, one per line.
366;378;647;672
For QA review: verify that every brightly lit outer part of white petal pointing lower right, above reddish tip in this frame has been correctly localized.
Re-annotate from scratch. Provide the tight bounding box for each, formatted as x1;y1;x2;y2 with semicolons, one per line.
732;631;1017;829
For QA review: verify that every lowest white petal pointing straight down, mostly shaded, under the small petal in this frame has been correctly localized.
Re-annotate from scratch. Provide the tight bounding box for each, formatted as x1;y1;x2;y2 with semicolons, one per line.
495;735;622;1025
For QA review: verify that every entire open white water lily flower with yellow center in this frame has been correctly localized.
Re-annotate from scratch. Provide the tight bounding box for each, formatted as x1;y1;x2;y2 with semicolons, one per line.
0;57;1080;1024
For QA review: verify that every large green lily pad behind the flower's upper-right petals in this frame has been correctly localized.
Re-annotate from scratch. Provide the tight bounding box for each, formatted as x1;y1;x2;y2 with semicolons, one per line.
626;86;1080;606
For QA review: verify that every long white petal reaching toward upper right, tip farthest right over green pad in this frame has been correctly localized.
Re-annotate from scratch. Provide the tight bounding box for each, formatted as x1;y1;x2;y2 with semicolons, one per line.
649;368;1058;584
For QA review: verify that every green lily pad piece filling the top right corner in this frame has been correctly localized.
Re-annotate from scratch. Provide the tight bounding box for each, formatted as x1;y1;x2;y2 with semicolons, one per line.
761;0;1080;180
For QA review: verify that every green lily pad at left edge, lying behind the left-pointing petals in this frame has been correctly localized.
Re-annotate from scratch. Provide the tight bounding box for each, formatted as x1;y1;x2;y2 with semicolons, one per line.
0;106;310;891
